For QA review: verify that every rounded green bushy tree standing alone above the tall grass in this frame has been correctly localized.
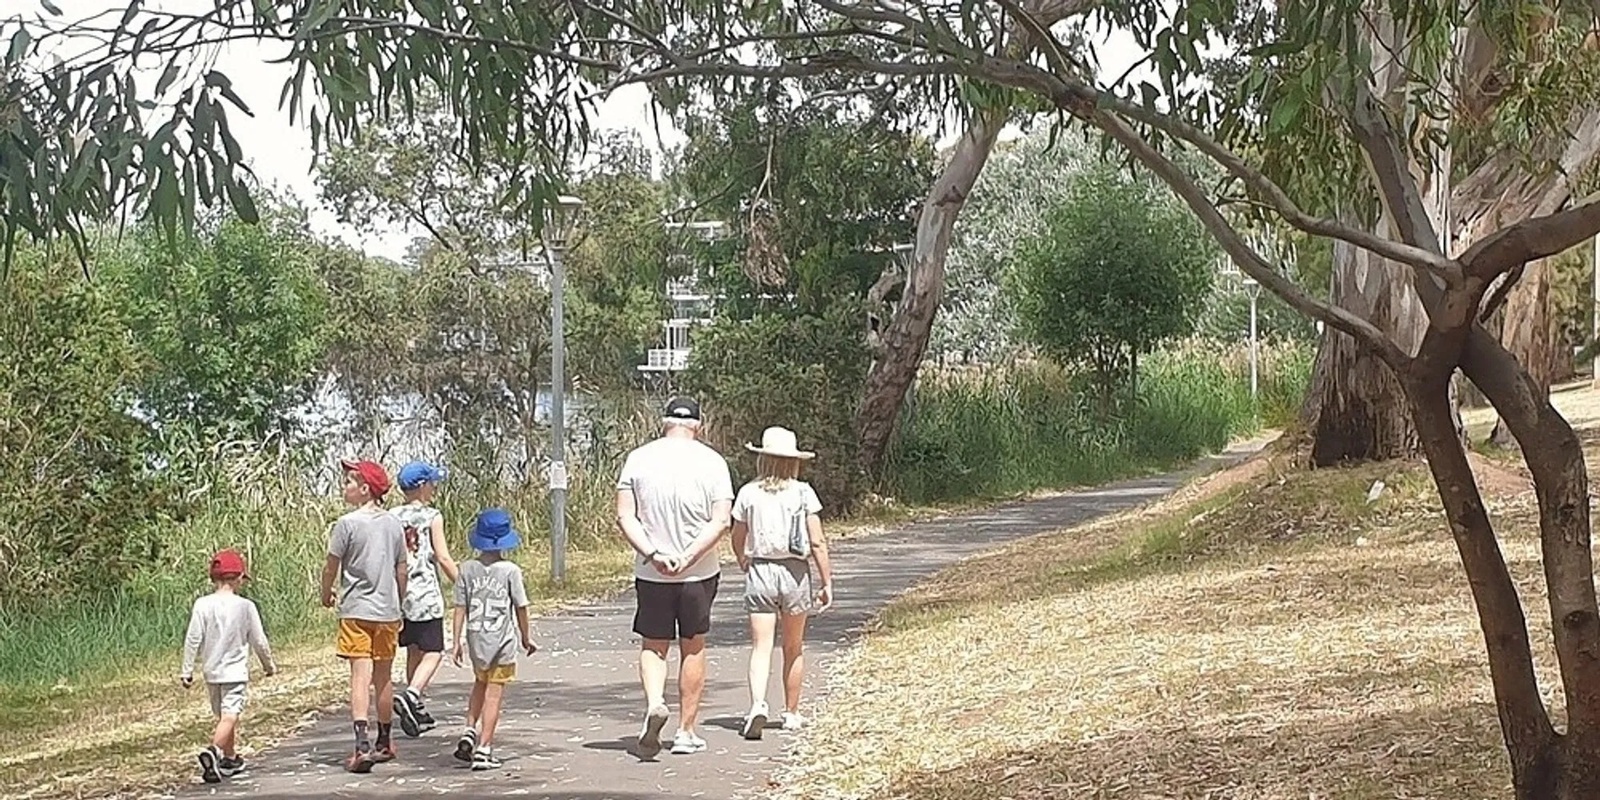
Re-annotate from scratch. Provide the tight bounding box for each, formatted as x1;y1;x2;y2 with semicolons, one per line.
1013;166;1216;390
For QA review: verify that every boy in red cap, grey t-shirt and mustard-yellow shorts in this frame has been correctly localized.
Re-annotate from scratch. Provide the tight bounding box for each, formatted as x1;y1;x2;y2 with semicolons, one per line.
322;461;406;773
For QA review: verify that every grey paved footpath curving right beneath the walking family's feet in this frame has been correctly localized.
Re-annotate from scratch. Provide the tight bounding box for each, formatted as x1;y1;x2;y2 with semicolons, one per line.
178;440;1262;800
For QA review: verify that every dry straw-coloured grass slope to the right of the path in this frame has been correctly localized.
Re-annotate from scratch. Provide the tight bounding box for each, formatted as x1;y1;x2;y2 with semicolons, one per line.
778;406;1600;800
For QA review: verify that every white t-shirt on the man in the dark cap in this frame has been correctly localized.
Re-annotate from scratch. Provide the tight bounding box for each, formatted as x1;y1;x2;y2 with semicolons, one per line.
616;437;733;584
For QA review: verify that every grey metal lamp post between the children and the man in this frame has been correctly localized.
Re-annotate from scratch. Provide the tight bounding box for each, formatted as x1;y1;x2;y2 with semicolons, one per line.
544;195;584;582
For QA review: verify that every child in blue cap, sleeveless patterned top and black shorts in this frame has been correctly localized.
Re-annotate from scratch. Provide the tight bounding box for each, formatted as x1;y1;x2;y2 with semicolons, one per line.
392;461;456;736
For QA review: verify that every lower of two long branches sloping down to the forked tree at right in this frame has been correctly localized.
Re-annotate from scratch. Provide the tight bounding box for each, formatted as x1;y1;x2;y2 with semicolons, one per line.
1090;110;1411;373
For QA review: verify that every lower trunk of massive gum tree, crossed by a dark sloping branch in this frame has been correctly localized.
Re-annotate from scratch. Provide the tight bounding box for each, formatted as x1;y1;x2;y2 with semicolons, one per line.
1301;233;1427;467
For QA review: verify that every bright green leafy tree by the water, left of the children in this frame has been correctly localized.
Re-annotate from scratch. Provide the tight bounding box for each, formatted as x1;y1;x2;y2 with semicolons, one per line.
98;208;328;442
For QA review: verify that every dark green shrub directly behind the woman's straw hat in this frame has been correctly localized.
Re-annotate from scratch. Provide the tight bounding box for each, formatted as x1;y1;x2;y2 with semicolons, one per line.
682;301;867;514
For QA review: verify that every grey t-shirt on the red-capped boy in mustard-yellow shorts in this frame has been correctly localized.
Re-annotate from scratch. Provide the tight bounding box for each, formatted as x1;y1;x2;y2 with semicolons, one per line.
328;509;405;622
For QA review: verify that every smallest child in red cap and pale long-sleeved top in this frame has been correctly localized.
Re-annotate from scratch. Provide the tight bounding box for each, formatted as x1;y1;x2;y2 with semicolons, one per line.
178;550;278;784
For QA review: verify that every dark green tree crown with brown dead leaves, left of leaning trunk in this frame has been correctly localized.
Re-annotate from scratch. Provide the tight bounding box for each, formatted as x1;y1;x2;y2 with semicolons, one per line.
674;87;934;315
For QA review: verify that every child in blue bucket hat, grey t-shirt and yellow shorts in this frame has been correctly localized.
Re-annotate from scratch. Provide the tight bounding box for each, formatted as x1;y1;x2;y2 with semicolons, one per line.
453;509;538;770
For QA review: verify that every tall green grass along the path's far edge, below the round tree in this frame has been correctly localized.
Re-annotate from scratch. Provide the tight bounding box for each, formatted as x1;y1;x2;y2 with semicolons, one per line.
883;344;1312;502
